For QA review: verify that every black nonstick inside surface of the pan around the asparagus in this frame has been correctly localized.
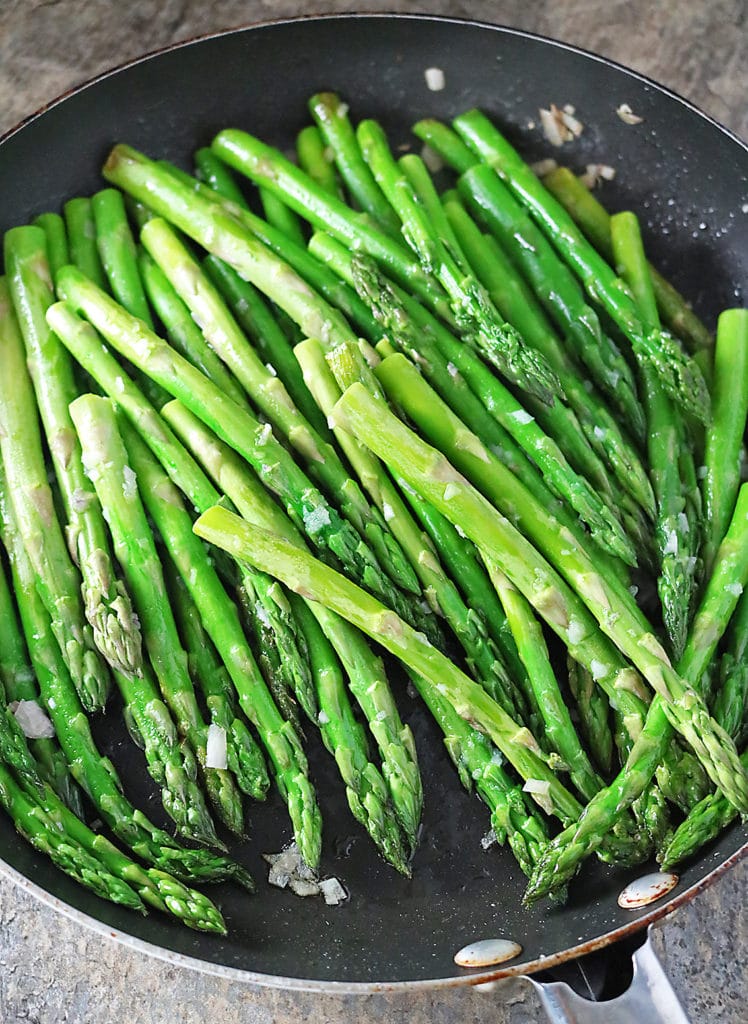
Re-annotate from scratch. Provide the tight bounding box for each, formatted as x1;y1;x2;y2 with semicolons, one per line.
0;16;748;987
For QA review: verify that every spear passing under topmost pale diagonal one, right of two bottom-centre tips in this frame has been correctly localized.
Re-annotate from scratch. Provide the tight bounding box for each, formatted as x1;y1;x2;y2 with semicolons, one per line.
159;401;422;849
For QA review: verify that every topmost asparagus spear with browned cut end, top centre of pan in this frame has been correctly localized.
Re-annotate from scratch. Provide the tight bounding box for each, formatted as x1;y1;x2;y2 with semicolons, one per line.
308;92;400;239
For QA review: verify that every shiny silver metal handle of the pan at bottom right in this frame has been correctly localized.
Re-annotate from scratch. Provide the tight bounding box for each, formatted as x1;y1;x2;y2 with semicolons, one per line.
528;937;689;1024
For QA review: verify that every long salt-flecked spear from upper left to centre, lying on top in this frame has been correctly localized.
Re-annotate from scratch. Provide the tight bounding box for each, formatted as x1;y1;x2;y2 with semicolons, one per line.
48;267;428;628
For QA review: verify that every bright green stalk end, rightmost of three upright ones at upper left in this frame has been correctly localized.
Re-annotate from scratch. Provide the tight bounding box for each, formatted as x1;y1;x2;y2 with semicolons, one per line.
91;188;154;328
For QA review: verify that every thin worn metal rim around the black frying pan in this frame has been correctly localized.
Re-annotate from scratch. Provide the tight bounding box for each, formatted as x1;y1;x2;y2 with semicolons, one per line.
0;11;748;996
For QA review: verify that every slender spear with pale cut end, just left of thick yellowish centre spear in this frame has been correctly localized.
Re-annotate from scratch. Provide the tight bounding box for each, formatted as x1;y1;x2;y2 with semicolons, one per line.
294;339;520;717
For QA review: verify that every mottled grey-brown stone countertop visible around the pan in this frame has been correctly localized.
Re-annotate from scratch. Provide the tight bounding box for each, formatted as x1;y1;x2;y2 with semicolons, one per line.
0;0;748;1024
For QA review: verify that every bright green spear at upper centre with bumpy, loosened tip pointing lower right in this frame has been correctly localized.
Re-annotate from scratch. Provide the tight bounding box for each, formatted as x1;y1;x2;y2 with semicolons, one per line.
357;121;560;406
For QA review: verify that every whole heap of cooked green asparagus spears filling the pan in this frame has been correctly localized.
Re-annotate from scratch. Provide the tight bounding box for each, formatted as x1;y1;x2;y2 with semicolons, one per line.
0;93;748;932
